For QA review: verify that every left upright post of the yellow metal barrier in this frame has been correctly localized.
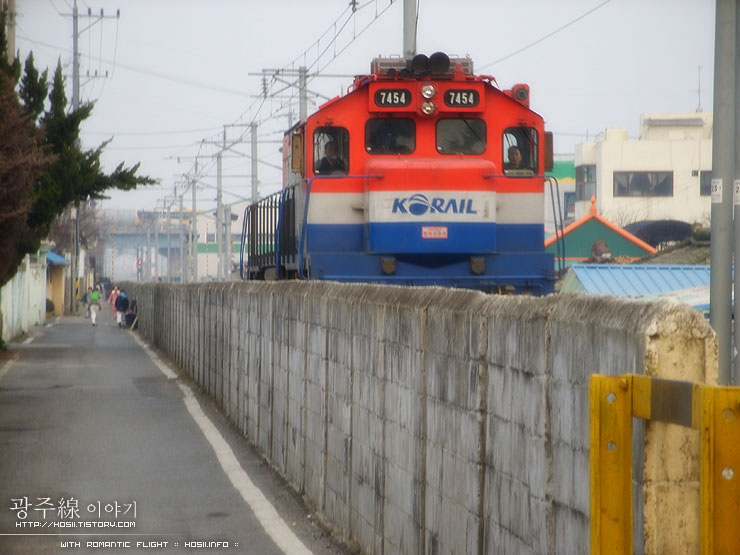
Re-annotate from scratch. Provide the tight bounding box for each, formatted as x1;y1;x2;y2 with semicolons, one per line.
589;375;632;555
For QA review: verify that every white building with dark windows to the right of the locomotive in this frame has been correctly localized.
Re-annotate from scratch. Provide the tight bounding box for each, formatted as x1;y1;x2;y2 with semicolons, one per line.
575;112;712;227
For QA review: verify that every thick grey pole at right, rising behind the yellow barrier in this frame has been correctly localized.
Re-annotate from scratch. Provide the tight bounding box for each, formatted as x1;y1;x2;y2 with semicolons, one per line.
709;0;740;385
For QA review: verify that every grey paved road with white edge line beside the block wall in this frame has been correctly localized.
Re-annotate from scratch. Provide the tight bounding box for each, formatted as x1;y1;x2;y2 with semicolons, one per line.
0;310;343;555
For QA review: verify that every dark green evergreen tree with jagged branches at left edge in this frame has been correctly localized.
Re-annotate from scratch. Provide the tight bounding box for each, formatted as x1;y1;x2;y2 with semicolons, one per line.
0;5;156;286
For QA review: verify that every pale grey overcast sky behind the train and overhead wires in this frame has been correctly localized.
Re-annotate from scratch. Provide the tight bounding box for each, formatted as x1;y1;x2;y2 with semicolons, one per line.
16;0;715;210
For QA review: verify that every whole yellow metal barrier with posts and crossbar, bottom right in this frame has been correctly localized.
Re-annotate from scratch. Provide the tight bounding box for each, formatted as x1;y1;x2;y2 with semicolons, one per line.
589;374;740;555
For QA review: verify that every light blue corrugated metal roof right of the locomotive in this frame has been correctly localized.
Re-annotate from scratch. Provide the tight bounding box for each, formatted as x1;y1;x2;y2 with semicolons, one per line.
570;264;709;297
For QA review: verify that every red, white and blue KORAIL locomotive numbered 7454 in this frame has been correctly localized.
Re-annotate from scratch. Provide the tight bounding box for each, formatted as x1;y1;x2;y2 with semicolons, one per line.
240;53;554;294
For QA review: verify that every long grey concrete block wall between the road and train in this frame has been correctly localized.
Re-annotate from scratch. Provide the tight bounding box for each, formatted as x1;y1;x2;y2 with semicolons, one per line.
128;282;716;554
